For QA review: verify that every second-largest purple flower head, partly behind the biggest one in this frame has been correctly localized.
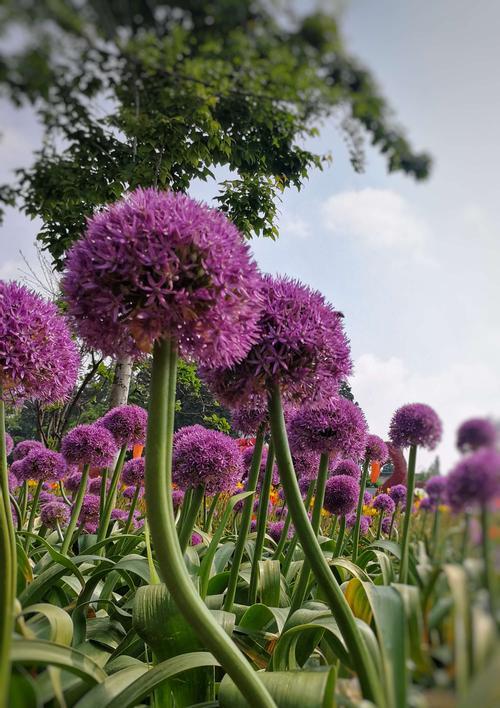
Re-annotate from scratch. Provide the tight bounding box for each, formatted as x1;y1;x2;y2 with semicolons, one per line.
202;275;351;406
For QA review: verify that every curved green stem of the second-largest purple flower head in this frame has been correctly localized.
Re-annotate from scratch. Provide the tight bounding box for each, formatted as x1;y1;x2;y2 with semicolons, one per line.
269;384;385;706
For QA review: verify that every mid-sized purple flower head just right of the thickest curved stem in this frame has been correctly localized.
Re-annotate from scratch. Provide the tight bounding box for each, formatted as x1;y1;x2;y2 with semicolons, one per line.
172;425;243;495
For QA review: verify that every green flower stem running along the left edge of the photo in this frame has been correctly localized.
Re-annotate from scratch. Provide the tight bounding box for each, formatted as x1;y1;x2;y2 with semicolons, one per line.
0;396;17;708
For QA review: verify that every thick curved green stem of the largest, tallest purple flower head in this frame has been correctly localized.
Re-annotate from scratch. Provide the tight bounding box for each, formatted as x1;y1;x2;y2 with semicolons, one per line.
146;340;276;708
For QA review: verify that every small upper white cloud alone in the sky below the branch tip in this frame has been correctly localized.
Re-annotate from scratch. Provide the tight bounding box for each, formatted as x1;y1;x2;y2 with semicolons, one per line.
323;188;430;253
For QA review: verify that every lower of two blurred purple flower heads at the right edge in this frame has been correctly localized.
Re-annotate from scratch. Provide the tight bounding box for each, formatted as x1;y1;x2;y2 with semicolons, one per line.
446;449;500;511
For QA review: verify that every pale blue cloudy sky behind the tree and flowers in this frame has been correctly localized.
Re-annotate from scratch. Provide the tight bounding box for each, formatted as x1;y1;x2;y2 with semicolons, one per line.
0;0;500;472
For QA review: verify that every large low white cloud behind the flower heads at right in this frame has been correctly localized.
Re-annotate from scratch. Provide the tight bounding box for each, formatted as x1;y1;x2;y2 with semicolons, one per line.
351;354;500;472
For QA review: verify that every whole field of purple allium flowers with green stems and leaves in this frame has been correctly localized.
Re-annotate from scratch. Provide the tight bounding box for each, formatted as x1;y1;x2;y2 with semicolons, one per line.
0;188;500;708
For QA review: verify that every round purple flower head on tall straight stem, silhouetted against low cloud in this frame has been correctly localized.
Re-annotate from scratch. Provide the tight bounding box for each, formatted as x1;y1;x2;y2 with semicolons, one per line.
389;403;443;450
